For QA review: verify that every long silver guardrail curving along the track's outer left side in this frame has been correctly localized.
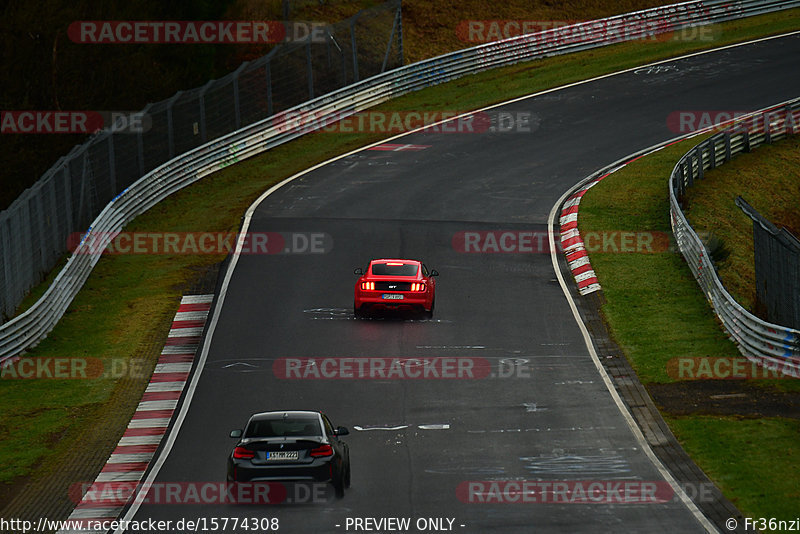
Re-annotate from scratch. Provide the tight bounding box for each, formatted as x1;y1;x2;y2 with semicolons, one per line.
0;0;800;362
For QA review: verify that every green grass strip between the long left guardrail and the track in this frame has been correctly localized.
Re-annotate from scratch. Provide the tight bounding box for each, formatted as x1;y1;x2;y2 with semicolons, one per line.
0;3;800;516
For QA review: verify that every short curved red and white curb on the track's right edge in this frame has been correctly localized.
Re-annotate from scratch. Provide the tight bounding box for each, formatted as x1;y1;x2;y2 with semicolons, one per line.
558;177;616;295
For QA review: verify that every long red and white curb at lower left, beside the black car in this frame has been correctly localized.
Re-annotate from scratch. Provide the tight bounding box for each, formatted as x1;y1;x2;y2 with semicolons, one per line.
59;295;214;534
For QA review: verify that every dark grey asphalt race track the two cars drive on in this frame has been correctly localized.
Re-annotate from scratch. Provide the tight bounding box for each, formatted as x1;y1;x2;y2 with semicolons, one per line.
125;36;800;533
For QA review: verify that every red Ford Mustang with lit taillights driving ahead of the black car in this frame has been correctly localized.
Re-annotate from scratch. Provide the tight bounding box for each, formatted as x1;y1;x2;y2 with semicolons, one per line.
353;259;439;318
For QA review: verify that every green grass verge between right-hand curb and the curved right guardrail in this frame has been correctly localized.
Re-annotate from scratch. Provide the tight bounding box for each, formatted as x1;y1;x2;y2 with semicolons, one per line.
578;138;800;519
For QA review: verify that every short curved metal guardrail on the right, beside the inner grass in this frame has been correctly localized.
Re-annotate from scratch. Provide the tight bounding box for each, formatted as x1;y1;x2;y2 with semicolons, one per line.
669;98;800;377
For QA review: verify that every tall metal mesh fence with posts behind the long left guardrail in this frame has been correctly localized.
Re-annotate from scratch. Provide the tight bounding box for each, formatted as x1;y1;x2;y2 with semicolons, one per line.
0;0;402;324
